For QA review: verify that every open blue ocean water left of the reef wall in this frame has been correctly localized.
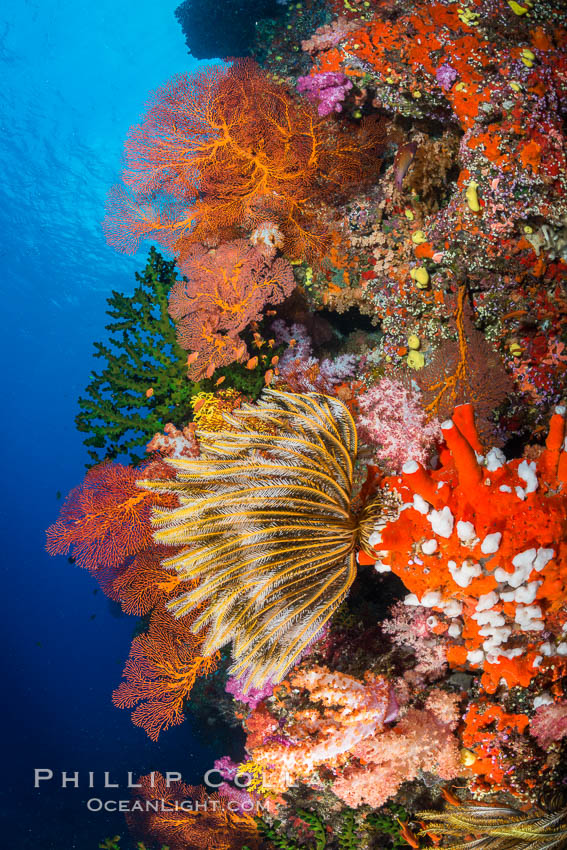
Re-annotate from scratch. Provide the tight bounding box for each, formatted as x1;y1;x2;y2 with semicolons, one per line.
0;0;235;850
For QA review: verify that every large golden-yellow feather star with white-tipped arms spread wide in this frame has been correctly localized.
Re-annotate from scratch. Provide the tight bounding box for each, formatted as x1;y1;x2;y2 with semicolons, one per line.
144;390;390;687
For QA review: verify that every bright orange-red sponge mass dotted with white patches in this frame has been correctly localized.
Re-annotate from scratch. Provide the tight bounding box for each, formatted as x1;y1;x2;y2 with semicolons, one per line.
360;405;567;692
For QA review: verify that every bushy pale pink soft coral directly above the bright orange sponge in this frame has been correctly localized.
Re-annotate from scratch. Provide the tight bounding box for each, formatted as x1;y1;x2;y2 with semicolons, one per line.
357;378;442;472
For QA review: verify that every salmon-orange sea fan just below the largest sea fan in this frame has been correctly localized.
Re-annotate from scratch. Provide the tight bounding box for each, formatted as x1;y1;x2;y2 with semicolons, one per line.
169;239;295;380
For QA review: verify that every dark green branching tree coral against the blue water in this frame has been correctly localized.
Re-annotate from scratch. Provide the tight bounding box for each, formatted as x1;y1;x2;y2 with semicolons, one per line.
75;248;196;463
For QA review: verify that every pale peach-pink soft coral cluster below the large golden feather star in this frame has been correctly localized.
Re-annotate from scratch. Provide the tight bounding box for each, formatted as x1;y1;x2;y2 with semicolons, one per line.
247;665;462;807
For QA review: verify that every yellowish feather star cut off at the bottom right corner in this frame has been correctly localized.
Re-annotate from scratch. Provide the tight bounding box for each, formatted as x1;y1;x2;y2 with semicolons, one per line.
419;805;567;850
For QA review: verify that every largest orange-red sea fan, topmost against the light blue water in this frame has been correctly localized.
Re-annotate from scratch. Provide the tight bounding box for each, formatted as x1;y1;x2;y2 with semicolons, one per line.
103;59;384;261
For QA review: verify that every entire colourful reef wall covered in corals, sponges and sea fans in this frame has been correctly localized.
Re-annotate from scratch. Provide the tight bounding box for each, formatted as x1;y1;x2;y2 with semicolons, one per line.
47;0;567;850
